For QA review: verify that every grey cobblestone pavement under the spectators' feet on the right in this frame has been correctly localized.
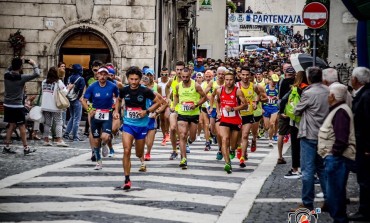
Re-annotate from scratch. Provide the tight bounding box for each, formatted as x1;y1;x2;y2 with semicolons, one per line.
244;149;359;223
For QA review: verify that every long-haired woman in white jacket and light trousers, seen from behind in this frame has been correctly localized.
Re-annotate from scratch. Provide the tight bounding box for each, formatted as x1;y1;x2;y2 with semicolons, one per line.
41;67;72;147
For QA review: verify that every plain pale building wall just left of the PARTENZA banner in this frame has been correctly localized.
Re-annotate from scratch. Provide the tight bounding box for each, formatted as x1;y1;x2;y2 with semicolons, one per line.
196;1;226;59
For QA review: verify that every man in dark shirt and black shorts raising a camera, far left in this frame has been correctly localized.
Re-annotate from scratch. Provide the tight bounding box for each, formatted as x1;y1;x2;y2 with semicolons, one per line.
3;58;40;155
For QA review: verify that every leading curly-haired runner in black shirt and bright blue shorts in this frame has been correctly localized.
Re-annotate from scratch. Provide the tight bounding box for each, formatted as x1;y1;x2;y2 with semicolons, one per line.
114;67;160;190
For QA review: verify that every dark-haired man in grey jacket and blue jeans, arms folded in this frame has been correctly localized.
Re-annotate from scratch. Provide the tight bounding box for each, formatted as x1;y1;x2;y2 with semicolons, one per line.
294;67;329;210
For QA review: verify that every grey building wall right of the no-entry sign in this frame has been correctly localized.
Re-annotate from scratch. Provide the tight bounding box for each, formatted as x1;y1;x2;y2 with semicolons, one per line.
328;0;357;66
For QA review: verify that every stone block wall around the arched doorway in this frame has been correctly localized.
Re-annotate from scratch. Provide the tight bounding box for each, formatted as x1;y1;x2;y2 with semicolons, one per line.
0;0;156;96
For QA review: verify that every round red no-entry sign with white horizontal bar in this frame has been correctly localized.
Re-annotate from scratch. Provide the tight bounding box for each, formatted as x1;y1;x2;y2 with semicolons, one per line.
302;2;329;29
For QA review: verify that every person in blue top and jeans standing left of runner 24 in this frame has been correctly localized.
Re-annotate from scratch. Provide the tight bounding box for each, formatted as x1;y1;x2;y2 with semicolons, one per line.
63;64;85;141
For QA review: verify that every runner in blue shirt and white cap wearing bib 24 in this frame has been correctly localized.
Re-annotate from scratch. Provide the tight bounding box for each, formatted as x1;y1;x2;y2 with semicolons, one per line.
82;67;119;170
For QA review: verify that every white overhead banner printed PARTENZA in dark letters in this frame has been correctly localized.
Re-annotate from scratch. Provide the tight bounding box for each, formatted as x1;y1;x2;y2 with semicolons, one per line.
229;13;305;29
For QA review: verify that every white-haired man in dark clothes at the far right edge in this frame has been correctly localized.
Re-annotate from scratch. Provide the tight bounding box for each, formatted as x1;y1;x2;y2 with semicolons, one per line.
349;67;370;221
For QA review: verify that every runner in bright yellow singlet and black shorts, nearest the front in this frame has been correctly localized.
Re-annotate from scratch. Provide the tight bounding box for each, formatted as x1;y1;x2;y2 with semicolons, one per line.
171;68;207;169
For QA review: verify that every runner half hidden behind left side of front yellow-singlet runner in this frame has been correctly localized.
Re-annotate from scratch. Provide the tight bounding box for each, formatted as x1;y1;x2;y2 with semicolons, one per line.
166;61;185;160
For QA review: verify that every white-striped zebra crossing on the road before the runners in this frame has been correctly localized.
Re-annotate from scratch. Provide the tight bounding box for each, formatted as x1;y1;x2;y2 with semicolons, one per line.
0;137;276;222
